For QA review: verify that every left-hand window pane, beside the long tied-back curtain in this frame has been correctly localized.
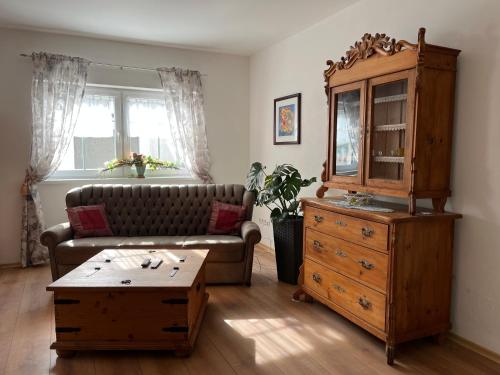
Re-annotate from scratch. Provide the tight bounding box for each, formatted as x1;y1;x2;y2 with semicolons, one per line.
59;94;116;170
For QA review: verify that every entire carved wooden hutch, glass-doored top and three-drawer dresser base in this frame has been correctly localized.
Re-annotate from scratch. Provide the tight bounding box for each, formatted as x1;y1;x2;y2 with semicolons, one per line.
294;29;461;364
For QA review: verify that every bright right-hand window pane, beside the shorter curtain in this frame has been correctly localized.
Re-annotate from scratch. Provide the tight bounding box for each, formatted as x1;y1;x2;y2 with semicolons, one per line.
125;96;177;161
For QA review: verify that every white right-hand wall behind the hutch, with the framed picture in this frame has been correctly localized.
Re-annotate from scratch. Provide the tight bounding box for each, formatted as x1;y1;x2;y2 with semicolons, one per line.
250;0;500;352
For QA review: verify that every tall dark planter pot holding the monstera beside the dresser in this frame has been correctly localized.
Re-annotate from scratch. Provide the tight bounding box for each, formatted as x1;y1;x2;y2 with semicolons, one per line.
273;216;304;285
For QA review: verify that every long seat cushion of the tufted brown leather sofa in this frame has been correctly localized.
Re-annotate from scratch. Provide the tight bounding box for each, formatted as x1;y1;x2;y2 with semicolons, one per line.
55;235;244;265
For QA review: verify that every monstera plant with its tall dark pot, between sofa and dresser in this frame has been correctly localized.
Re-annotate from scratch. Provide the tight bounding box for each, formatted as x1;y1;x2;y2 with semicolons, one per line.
246;162;316;284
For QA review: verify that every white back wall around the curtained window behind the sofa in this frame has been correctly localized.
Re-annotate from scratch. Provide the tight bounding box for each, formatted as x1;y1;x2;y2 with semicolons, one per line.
0;29;249;264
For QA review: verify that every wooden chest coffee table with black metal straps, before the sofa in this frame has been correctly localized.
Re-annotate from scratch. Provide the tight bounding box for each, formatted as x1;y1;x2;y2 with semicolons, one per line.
47;249;208;357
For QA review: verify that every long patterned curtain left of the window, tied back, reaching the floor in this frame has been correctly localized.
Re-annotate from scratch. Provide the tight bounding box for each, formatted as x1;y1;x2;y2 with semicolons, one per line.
21;53;90;267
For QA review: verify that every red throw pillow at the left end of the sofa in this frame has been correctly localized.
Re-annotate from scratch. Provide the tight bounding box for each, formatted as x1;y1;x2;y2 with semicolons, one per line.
66;203;113;238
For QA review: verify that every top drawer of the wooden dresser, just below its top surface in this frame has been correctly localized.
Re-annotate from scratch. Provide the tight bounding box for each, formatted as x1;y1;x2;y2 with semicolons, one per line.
304;206;389;252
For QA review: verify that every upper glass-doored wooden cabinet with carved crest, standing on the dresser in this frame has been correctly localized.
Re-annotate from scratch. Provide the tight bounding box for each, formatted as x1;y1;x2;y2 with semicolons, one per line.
317;28;460;213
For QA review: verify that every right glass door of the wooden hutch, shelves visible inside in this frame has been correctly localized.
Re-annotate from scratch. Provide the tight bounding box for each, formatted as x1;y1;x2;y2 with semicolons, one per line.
367;73;411;184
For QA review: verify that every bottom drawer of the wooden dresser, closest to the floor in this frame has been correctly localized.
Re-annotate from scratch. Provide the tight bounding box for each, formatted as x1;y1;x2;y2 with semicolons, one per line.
304;259;385;330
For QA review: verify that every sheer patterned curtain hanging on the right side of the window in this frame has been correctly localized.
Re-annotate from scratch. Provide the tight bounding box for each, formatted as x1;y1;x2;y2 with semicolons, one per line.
157;68;213;184
